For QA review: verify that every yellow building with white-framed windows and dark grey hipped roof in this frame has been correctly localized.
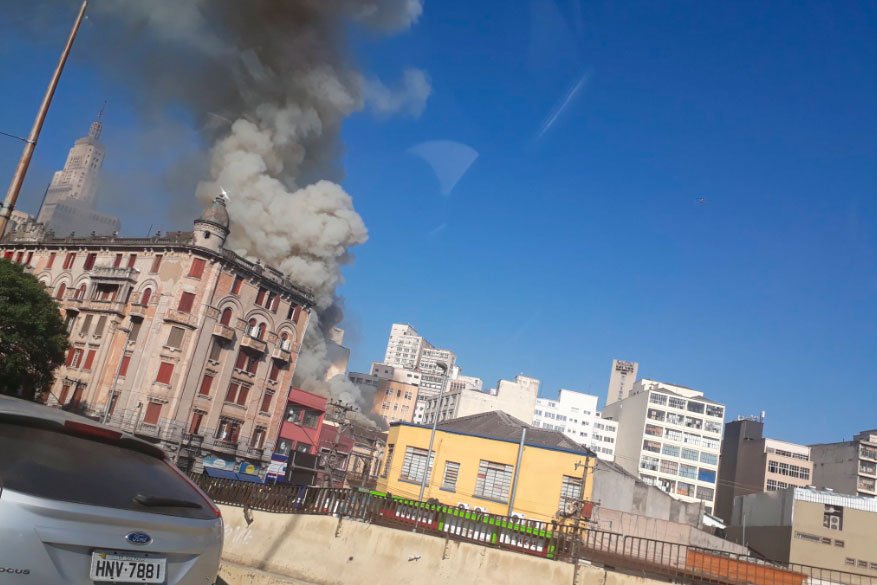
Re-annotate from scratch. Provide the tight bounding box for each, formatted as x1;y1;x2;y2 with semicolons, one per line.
377;411;596;522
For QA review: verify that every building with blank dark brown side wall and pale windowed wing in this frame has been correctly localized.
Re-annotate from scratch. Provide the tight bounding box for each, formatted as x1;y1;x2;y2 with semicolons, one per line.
715;416;813;522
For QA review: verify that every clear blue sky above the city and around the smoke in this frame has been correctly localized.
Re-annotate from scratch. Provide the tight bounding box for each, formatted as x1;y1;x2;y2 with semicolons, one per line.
0;0;877;443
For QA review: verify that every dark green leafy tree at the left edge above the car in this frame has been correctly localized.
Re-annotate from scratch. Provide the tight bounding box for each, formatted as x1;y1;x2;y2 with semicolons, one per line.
0;260;68;400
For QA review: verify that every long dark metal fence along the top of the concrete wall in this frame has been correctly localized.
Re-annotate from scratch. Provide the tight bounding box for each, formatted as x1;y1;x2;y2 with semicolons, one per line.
193;475;877;585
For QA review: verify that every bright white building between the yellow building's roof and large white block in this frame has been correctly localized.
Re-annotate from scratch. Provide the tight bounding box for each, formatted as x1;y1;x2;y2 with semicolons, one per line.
533;390;618;461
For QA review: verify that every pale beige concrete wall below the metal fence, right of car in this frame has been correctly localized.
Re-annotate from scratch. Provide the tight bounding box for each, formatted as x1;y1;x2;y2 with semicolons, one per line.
220;506;672;585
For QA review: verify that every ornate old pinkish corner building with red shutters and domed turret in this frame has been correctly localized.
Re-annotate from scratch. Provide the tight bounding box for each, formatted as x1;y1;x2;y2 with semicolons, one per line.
0;198;314;474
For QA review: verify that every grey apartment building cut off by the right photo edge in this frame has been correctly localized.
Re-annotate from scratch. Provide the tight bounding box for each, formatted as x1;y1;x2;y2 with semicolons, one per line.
810;429;877;498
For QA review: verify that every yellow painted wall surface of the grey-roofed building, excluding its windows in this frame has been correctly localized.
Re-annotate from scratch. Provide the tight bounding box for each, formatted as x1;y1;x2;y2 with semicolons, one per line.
377;425;595;522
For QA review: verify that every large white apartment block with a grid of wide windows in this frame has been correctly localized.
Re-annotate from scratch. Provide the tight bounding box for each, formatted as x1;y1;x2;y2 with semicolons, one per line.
603;379;725;514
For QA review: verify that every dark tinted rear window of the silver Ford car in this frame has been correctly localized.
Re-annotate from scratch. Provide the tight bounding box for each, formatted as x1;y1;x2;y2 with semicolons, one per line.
0;422;216;520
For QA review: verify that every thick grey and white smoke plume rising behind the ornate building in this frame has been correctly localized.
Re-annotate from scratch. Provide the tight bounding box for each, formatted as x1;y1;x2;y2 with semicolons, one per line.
16;0;430;420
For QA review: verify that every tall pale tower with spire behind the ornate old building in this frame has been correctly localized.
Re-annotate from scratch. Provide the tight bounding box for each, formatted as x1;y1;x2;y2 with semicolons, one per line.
37;103;120;237
